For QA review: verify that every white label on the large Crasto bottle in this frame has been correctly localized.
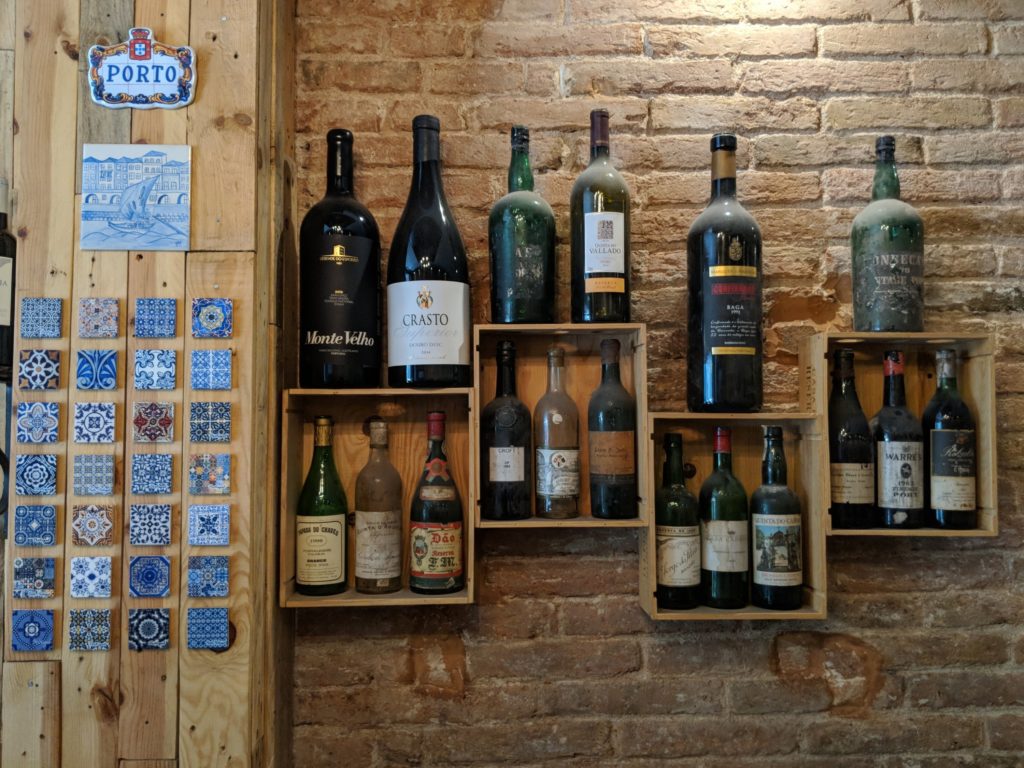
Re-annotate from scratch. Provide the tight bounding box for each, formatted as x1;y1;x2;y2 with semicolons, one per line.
387;280;470;367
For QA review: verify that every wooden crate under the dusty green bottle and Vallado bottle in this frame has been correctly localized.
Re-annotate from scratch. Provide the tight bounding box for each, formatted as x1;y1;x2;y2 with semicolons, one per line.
473;323;649;528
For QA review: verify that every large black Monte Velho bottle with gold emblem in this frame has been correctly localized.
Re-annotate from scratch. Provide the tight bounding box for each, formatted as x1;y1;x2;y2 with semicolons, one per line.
299;128;381;388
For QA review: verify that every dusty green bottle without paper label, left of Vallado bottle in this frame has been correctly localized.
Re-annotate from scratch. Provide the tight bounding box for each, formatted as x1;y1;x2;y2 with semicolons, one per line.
487;125;556;323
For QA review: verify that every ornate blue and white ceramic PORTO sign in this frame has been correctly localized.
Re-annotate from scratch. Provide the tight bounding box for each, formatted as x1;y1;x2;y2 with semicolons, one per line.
89;27;196;110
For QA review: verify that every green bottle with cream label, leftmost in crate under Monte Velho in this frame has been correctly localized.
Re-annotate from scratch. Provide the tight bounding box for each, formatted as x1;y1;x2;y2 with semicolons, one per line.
295;416;348;595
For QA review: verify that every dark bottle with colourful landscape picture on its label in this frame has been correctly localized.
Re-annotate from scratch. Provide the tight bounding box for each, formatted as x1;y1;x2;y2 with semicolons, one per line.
751;427;804;610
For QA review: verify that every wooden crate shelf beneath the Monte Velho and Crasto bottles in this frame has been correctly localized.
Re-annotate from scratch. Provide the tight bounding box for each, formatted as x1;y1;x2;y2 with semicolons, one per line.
279;387;476;608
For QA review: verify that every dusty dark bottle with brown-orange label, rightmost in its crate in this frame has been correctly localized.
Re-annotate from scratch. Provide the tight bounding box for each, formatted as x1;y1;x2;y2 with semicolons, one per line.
587;339;638;519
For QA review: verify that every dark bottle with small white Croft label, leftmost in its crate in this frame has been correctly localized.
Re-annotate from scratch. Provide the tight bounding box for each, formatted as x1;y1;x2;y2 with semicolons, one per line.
480;341;534;520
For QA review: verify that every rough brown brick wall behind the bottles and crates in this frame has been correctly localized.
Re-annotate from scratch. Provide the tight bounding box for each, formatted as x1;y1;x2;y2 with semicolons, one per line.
294;0;1024;768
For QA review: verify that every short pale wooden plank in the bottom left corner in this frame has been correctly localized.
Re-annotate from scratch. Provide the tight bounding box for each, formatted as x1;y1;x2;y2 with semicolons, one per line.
0;662;60;768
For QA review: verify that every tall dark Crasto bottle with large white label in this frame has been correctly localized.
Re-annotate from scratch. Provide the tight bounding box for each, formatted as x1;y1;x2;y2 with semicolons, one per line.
387;115;472;387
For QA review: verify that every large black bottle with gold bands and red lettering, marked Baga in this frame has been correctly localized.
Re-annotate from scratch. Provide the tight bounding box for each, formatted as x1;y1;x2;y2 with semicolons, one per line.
686;133;762;412
